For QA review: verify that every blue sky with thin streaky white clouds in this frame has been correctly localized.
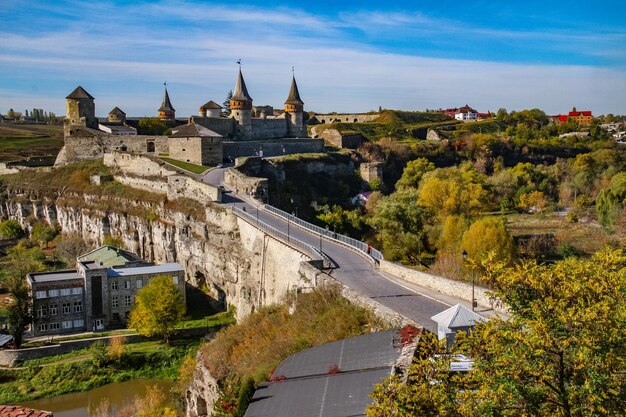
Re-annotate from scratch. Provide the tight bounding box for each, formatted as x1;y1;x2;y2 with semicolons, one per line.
0;0;626;117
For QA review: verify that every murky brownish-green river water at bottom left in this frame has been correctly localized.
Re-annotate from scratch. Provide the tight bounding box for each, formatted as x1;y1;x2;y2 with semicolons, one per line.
20;379;174;417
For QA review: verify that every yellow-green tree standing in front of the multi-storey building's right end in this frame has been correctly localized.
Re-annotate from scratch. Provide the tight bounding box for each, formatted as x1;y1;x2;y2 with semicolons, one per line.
128;275;185;343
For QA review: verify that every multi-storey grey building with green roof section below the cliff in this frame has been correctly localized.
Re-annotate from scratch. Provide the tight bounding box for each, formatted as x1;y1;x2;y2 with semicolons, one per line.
27;246;185;336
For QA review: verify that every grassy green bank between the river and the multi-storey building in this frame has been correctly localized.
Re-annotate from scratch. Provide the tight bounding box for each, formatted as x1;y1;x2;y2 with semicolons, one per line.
0;340;199;404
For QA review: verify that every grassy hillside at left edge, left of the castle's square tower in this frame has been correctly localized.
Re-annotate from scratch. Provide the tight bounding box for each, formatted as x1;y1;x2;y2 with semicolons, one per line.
0;124;63;162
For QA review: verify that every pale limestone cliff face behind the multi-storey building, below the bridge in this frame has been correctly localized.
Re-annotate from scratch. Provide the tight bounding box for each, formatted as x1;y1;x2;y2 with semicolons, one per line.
0;190;307;317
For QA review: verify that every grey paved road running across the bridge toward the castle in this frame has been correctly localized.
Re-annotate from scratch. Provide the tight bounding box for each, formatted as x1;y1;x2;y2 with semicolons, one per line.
201;167;463;332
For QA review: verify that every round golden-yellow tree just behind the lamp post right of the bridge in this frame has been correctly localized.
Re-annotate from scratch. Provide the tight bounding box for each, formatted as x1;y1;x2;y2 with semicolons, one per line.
461;217;513;263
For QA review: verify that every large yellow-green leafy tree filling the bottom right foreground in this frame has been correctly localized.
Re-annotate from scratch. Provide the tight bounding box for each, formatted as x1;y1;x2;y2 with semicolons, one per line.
367;250;626;417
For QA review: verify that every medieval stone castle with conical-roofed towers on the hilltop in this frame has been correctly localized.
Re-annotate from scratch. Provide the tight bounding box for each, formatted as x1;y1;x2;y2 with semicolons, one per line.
55;68;324;165
